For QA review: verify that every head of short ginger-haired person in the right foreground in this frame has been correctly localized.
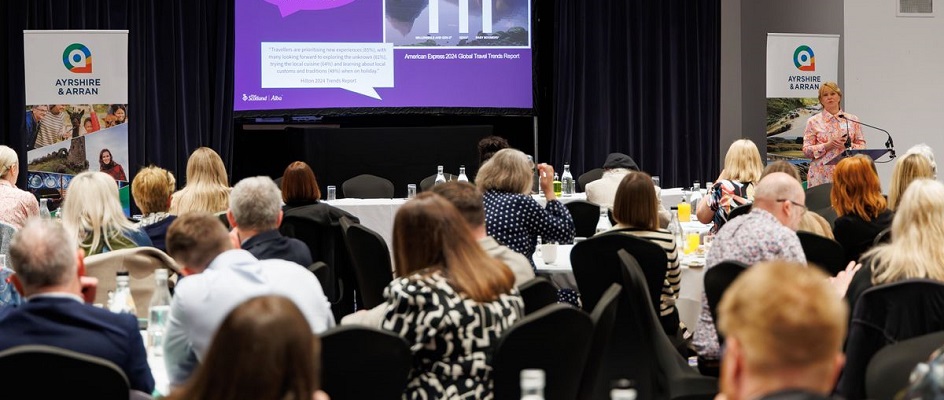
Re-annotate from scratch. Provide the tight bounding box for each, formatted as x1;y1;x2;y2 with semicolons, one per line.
717;260;848;400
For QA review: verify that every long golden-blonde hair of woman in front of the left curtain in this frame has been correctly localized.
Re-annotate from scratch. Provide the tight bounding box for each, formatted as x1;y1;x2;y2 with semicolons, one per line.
170;147;230;215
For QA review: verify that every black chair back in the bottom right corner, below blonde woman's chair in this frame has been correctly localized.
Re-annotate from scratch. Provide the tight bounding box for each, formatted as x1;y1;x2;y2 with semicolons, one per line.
865;332;944;400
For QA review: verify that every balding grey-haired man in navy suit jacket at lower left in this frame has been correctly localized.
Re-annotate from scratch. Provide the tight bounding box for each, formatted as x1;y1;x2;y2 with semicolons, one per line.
0;219;154;393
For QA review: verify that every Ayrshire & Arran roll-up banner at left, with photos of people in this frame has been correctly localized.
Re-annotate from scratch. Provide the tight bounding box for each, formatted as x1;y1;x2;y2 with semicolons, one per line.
23;31;130;214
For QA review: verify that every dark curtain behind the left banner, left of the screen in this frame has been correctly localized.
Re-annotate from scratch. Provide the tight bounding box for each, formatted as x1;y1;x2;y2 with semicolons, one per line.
0;0;233;187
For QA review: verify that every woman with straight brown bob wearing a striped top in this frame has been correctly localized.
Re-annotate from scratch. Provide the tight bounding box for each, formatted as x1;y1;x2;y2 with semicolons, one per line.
605;172;691;339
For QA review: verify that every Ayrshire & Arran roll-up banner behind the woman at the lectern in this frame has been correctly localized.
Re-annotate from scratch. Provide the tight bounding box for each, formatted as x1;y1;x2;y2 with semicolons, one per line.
767;33;839;185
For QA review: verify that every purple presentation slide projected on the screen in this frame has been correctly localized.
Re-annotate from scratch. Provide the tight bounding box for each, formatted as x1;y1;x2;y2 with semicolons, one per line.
234;0;533;111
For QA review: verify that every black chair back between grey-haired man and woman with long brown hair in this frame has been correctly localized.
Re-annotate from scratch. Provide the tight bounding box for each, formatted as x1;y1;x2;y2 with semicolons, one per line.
341;218;393;309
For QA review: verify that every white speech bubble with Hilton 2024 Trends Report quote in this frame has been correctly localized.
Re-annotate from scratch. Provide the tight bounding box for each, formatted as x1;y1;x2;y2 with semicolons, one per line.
261;42;393;100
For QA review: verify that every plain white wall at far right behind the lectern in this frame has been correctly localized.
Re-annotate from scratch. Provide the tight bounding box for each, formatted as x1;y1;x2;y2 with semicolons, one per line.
843;0;944;190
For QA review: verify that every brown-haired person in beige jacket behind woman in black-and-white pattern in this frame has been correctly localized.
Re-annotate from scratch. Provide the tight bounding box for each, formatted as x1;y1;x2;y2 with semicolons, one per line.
432;182;534;287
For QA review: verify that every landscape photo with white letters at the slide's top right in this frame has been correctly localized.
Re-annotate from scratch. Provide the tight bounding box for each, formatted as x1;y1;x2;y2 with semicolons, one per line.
384;0;531;47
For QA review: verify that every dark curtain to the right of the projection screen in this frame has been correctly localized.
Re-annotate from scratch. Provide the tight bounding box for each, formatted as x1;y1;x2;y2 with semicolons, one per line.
551;0;721;187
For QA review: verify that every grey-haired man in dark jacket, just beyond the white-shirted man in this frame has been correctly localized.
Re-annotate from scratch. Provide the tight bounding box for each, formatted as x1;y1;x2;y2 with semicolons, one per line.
226;176;312;267
